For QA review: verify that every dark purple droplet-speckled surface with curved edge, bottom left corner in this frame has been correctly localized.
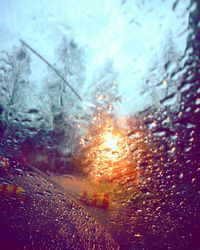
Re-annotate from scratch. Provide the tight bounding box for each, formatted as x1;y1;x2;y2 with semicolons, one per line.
0;162;119;250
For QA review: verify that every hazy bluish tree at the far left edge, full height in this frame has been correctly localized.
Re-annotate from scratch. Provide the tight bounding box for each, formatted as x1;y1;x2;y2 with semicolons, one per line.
0;46;31;154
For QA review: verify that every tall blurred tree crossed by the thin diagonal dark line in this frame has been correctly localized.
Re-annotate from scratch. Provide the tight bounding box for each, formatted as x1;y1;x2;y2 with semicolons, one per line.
44;38;85;158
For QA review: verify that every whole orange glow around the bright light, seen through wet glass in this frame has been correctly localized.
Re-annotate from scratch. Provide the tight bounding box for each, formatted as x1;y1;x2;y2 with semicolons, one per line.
76;113;139;187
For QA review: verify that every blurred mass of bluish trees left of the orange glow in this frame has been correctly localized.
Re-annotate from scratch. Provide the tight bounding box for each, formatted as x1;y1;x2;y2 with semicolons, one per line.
0;38;119;171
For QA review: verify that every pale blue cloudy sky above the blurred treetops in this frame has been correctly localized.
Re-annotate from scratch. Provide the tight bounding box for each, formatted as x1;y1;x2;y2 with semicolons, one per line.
0;0;190;112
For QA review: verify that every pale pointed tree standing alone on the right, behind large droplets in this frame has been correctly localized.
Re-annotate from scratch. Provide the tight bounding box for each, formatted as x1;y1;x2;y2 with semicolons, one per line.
144;33;182;107
